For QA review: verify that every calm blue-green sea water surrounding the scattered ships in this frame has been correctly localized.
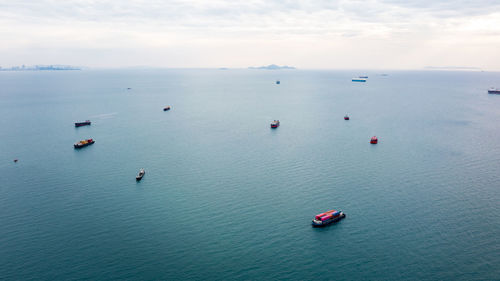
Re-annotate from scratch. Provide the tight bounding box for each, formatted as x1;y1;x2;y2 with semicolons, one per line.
0;70;500;280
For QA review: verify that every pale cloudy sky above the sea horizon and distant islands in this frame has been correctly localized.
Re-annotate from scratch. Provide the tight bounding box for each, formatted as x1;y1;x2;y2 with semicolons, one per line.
0;0;500;70
